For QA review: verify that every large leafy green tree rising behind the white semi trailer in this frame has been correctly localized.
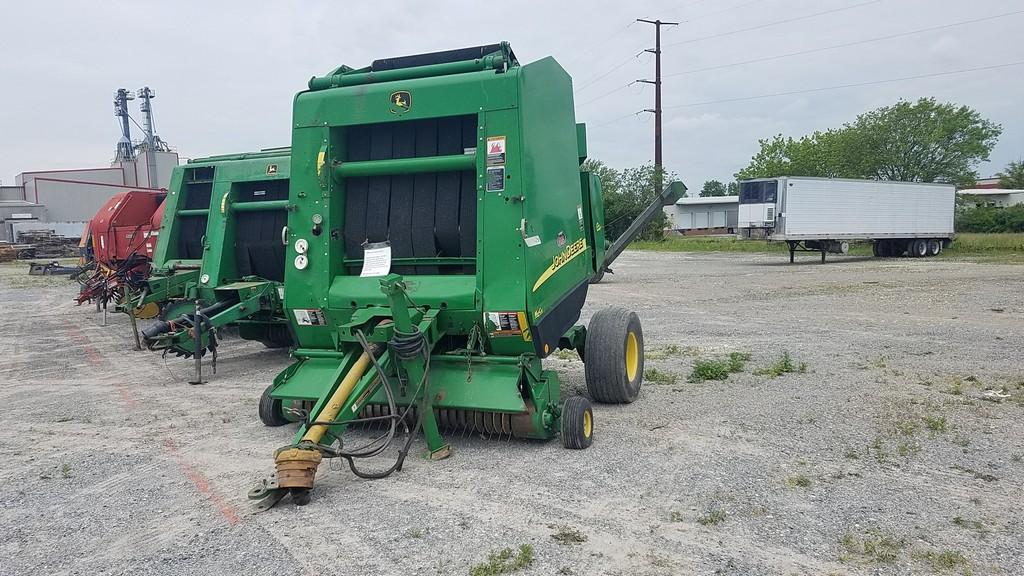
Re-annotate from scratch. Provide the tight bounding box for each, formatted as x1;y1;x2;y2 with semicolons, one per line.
736;98;1002;186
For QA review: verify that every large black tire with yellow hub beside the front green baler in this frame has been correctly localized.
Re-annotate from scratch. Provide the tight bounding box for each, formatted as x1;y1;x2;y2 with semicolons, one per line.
584;306;643;404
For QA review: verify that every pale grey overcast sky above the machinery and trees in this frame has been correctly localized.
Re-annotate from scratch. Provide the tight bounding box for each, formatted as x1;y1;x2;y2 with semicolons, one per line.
0;0;1024;189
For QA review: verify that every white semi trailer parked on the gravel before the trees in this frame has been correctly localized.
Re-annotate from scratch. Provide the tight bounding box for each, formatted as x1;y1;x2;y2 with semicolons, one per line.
737;176;956;262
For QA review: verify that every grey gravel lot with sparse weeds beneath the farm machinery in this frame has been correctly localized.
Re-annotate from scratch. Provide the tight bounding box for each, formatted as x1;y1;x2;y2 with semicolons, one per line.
0;252;1024;575
